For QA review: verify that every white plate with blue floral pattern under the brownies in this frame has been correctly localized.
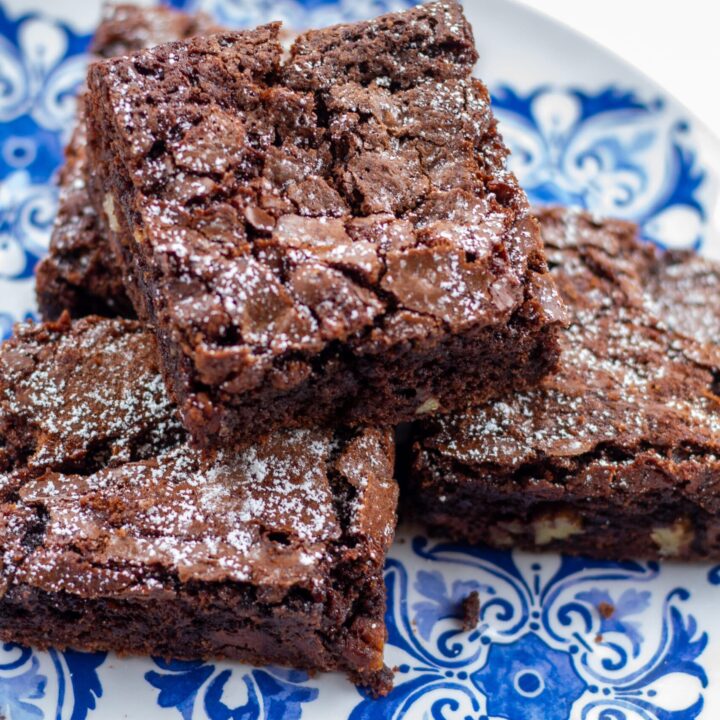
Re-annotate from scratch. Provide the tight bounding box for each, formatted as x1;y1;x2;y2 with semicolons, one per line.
0;0;720;720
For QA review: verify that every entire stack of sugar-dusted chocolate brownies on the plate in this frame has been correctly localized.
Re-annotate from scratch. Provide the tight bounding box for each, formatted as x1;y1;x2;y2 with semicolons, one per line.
0;0;720;694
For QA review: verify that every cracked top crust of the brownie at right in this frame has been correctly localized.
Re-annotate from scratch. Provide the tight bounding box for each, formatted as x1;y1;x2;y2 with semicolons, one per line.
422;209;720;500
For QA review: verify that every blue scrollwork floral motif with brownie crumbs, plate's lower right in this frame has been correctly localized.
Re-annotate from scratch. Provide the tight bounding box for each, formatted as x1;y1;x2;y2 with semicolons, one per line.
351;538;707;720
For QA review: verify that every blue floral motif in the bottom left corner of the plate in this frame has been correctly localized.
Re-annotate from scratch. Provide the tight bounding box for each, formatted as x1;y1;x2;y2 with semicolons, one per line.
0;643;106;720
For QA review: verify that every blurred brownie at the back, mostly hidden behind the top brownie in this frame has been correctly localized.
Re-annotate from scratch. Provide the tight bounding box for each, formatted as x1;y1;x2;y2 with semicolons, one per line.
37;5;217;320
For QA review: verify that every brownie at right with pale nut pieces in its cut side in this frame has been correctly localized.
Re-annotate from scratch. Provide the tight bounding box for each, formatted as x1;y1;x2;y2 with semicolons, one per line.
407;209;720;559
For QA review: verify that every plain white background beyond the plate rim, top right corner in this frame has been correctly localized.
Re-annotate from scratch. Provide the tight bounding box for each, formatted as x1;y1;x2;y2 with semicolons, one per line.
516;0;720;137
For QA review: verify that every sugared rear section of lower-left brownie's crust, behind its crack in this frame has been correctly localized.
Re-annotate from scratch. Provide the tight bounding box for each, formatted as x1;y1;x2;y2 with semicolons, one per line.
0;320;182;471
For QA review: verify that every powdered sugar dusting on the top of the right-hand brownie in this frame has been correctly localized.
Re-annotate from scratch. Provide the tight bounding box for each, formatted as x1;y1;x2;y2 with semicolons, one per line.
428;213;720;473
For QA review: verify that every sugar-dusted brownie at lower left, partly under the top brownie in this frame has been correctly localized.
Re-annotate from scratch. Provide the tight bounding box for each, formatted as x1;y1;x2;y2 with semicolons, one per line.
0;316;397;693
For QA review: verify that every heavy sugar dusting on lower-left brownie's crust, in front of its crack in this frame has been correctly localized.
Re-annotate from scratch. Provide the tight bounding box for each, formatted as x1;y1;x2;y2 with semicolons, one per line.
6;424;342;592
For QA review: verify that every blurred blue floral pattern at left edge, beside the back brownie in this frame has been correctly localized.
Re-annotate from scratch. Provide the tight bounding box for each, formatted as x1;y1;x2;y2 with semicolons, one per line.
0;3;90;340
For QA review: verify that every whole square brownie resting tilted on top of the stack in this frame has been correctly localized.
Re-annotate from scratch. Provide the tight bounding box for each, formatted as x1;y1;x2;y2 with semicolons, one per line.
89;2;561;446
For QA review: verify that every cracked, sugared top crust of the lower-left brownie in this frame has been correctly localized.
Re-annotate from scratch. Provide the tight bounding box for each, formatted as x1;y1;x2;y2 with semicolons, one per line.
0;316;397;601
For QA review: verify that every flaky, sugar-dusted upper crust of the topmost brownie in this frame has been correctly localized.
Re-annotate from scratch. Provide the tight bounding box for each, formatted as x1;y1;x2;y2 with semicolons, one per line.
86;2;537;400
